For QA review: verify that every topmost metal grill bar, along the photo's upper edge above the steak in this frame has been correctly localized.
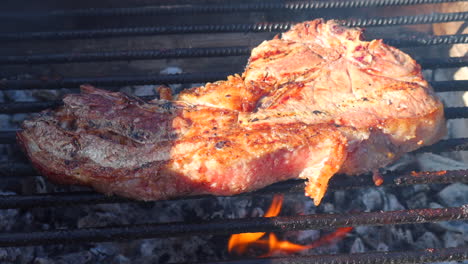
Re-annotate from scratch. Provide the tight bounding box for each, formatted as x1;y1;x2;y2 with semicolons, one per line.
0;0;460;18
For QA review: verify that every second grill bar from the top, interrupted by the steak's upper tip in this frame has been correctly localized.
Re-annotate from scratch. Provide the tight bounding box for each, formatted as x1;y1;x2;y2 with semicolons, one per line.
0;12;468;41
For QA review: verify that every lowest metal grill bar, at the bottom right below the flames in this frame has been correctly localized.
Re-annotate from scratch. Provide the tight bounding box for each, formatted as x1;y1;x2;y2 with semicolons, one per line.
205;247;468;264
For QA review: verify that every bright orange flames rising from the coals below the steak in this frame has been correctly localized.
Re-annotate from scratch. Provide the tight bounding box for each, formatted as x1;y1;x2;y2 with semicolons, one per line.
228;195;353;257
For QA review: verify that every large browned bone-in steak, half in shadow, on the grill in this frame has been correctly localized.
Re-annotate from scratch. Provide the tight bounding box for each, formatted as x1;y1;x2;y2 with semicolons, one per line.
18;20;445;204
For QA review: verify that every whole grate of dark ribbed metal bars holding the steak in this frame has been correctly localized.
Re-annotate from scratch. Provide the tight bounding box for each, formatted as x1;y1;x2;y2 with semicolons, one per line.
0;0;468;263
